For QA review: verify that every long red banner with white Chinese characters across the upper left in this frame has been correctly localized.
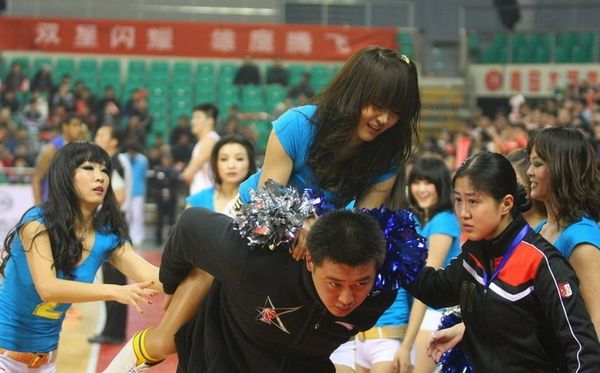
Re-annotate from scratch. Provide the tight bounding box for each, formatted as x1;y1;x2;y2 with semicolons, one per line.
0;17;397;61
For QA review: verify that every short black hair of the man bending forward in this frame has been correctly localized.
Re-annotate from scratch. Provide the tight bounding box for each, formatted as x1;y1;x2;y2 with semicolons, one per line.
306;210;386;268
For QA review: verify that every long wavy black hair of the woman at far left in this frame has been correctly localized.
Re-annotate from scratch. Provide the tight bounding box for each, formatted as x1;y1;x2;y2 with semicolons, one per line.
0;141;129;277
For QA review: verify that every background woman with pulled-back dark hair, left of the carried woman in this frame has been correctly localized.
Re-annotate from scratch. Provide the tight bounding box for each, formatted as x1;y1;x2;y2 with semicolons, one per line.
186;135;256;212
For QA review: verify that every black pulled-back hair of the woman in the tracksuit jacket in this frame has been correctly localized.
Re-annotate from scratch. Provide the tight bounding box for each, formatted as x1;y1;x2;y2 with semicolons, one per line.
452;151;531;216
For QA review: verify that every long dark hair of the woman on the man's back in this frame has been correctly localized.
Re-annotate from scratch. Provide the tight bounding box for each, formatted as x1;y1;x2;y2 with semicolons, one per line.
308;47;421;205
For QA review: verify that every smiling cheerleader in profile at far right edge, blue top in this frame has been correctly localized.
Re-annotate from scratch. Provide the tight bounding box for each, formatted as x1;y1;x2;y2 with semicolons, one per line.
527;127;600;336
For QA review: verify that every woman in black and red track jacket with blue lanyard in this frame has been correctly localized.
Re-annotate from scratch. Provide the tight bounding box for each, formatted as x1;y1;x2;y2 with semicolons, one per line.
408;152;600;373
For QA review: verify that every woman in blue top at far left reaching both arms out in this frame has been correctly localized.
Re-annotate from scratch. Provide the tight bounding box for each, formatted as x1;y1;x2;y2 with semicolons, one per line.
0;142;162;373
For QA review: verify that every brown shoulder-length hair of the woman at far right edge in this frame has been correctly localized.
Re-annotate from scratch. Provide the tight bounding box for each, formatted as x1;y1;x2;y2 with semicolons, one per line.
527;127;600;225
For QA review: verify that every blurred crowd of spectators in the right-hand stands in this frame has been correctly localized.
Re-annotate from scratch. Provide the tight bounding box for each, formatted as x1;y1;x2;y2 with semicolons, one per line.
417;81;600;170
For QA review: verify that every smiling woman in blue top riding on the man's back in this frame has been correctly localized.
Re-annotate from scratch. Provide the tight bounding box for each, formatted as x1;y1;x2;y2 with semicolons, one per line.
107;47;421;372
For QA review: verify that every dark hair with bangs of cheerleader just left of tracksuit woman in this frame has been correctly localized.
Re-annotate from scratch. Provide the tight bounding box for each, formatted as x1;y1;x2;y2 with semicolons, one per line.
408;157;452;224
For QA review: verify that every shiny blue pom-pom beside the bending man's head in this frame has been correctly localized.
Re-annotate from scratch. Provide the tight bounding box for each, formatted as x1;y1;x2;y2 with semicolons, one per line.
361;207;427;291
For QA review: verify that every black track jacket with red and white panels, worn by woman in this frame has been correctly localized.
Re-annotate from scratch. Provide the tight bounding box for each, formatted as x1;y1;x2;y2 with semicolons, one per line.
408;215;600;373
